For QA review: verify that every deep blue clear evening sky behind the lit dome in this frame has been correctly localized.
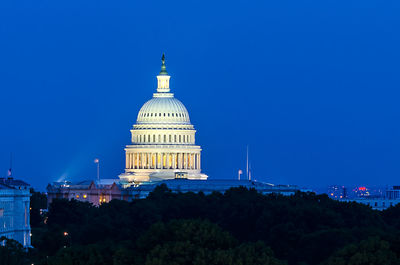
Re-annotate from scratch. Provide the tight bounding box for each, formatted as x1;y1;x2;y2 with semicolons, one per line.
0;0;400;190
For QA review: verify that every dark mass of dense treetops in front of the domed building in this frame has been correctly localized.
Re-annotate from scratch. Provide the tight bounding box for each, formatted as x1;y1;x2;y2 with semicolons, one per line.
4;186;400;265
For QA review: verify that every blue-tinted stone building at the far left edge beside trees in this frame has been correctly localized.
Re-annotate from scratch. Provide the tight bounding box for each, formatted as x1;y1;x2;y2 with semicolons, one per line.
0;177;31;247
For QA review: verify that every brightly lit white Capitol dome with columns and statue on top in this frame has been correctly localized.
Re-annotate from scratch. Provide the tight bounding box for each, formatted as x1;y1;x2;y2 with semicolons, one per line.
119;55;207;183
